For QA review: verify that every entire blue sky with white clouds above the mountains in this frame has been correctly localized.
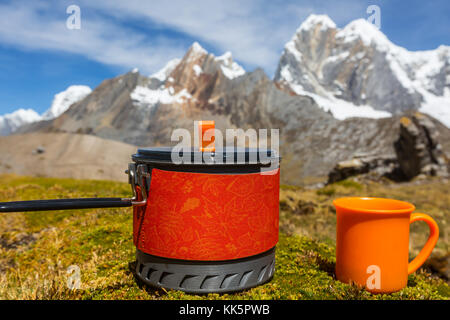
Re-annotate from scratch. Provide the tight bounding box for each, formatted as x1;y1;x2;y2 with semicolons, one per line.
0;0;450;114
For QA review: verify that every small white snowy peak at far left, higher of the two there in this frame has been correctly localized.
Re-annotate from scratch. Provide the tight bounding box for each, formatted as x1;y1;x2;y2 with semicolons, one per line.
42;85;92;120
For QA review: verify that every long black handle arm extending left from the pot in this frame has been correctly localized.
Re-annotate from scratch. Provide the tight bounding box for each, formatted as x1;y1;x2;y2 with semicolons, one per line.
0;198;132;212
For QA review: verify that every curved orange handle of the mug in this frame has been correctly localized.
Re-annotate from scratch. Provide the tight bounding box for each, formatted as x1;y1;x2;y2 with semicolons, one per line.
408;213;439;274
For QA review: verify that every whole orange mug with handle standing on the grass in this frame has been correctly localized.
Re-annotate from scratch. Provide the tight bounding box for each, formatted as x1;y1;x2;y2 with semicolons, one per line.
333;198;439;293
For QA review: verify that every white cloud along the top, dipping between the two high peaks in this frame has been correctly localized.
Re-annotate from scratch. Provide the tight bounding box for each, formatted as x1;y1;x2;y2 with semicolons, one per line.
79;0;365;73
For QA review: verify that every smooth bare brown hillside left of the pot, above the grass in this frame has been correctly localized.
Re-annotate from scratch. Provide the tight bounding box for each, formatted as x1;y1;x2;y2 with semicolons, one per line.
0;133;136;182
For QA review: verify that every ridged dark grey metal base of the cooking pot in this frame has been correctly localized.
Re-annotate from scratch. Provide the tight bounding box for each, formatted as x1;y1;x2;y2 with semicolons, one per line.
136;248;275;293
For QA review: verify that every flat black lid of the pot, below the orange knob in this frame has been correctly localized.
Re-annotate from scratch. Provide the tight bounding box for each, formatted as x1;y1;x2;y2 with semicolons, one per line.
132;147;280;165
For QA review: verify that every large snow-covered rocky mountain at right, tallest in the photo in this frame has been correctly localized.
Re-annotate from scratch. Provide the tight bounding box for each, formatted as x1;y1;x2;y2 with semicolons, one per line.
274;15;450;127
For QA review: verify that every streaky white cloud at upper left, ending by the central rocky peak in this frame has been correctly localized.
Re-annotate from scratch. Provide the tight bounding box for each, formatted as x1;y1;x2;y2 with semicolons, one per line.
0;2;185;71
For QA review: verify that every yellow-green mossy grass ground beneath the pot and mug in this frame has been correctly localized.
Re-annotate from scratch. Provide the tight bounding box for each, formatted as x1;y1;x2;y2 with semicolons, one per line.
0;175;450;299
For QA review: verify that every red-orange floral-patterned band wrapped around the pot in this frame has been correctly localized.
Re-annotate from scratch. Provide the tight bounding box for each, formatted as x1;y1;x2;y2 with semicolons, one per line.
133;169;280;261
